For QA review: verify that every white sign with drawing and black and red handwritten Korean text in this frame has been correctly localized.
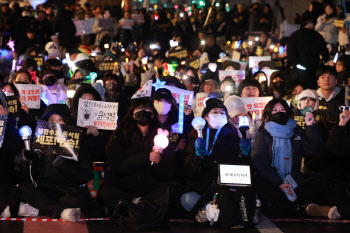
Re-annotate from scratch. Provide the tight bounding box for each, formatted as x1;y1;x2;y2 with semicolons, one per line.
77;99;119;130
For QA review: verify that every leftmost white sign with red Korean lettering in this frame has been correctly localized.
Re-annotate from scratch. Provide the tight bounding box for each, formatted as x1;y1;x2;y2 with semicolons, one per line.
15;84;41;109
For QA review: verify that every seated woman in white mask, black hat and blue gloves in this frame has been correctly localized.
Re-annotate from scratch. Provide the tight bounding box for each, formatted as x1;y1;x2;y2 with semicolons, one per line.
181;98;239;216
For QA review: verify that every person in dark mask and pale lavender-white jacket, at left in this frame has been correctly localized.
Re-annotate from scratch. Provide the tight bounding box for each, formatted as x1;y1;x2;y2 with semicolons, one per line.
40;70;68;105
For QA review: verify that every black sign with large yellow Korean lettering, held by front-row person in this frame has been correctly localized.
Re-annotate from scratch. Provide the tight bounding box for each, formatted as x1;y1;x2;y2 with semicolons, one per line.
33;120;83;160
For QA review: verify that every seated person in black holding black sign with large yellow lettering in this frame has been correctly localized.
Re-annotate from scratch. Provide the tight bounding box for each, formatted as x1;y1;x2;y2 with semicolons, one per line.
19;104;93;222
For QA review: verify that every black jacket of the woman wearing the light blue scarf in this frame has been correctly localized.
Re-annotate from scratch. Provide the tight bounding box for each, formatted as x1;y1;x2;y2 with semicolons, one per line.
251;125;322;186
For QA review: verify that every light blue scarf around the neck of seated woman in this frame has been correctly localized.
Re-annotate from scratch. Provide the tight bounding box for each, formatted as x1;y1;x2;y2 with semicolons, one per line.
265;119;296;179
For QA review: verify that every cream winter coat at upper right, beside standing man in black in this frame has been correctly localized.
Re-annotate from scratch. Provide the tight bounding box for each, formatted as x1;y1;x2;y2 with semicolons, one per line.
315;14;338;44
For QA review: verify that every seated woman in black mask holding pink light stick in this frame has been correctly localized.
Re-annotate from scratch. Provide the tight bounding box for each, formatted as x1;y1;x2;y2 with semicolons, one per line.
98;99;173;220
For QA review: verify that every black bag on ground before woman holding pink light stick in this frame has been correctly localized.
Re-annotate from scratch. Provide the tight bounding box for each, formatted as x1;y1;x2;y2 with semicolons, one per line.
112;186;170;230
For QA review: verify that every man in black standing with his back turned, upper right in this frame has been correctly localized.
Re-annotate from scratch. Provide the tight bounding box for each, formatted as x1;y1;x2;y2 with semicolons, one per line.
287;20;329;89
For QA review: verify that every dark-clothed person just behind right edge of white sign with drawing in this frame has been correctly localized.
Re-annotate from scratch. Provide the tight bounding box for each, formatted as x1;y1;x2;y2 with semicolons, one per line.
102;73;130;120
